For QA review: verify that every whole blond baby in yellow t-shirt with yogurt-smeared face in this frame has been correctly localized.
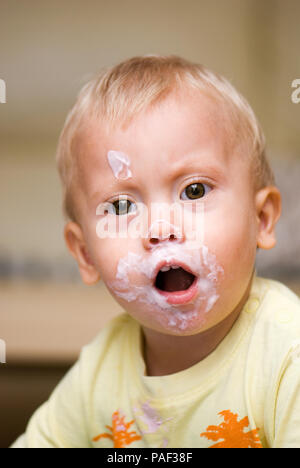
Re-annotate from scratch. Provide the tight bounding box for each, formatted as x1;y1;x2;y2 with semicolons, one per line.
13;56;300;448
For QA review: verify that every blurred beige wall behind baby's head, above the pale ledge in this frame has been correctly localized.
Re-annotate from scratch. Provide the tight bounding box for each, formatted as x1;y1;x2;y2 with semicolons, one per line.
0;0;300;279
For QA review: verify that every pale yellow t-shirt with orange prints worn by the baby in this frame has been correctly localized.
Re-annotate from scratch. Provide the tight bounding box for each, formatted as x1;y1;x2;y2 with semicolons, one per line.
13;277;300;448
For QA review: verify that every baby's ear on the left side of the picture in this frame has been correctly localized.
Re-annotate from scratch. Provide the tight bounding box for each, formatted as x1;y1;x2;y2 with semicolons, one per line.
64;222;100;285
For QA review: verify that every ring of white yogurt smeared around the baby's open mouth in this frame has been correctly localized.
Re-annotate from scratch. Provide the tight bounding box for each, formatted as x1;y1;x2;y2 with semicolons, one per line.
107;244;224;330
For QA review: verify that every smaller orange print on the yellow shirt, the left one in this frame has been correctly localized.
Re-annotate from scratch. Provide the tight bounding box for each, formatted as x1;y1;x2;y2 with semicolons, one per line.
93;411;141;448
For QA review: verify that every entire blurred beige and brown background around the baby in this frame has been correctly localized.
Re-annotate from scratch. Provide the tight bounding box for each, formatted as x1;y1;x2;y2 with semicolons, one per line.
0;0;300;447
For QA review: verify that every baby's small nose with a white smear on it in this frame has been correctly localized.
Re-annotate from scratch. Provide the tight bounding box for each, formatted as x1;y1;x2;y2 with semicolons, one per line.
143;219;184;250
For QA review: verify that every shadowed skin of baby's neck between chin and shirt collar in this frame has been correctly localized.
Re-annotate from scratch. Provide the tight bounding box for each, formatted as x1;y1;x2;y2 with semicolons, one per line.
142;275;253;376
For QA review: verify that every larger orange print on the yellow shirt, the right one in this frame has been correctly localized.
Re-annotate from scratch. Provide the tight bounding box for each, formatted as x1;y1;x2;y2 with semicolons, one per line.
200;410;263;448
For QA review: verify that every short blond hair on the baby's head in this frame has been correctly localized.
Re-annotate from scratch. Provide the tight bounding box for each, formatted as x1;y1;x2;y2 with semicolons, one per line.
57;55;275;221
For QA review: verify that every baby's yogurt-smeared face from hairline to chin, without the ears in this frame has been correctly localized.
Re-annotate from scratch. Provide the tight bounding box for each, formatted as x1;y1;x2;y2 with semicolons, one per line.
76;88;258;335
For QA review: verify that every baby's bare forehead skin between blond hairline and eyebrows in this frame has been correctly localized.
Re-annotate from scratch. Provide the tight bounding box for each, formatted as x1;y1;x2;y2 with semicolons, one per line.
76;91;244;189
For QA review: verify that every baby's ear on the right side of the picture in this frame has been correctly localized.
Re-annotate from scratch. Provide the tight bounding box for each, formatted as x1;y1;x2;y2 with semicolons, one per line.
255;185;281;249
